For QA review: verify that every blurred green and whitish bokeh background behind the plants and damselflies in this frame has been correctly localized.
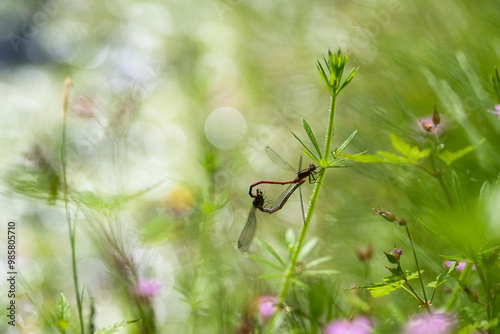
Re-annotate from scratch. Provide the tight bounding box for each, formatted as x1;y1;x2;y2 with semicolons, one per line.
0;0;500;333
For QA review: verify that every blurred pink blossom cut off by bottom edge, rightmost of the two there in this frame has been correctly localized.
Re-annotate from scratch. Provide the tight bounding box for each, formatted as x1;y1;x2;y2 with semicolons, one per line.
404;313;455;334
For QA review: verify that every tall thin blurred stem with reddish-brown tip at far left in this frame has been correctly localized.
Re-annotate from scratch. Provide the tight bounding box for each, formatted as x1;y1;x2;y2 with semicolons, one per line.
61;78;84;334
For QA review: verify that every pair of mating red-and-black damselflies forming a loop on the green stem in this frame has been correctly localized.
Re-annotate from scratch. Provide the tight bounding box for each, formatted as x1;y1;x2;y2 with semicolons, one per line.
238;146;318;252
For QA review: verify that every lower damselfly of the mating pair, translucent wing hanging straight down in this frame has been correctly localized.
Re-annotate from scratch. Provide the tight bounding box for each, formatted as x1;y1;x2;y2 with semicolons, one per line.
238;179;306;252
